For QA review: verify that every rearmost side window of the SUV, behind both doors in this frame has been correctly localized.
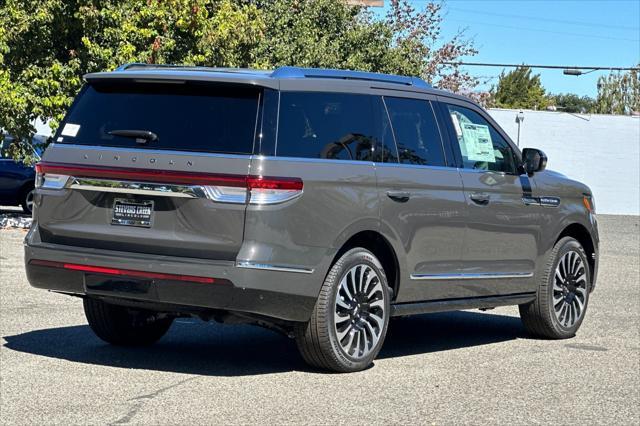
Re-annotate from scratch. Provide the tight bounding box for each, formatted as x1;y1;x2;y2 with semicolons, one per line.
276;92;380;161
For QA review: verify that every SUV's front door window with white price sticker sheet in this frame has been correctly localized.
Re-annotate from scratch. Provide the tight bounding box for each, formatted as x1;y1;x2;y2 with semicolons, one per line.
447;105;516;173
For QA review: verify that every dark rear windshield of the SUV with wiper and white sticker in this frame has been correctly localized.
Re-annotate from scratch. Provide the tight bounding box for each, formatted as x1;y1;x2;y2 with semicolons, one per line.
56;82;260;154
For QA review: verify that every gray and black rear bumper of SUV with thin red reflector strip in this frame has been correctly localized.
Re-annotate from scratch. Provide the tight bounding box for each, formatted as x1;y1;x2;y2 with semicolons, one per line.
24;240;317;321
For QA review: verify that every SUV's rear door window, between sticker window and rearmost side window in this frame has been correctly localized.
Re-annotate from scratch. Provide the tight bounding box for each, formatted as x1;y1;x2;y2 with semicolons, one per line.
384;97;445;166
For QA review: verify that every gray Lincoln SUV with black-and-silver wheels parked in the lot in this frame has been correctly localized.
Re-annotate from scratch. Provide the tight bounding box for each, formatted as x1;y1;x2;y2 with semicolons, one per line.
25;64;598;372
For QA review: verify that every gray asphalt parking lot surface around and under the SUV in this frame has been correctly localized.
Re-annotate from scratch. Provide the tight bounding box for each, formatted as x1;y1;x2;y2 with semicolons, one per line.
0;216;640;425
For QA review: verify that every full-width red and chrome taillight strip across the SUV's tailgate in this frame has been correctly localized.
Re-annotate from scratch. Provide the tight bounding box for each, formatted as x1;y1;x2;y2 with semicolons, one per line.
36;162;303;205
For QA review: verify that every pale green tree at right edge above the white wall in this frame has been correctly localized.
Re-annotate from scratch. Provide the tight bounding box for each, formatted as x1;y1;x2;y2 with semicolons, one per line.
595;68;640;114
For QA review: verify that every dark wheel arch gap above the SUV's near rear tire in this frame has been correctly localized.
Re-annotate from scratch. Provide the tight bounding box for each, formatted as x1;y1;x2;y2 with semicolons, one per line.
331;230;400;301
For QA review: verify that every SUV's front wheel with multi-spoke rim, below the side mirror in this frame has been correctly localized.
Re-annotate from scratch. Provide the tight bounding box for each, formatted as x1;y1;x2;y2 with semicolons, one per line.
519;237;591;339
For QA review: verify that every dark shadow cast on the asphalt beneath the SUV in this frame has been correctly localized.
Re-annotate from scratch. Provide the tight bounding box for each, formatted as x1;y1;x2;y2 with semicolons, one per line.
4;312;525;376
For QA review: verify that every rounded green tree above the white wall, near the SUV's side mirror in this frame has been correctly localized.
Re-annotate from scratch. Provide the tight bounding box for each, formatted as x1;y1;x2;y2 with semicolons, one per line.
491;67;549;109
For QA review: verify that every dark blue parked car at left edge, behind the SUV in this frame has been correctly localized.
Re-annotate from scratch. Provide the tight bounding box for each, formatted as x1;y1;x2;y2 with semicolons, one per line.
0;135;44;214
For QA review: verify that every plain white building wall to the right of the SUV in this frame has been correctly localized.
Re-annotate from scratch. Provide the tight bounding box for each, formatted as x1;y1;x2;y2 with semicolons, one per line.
489;109;640;215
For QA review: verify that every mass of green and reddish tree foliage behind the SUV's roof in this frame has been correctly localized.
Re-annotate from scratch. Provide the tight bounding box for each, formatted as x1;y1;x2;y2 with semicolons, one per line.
0;0;477;163
